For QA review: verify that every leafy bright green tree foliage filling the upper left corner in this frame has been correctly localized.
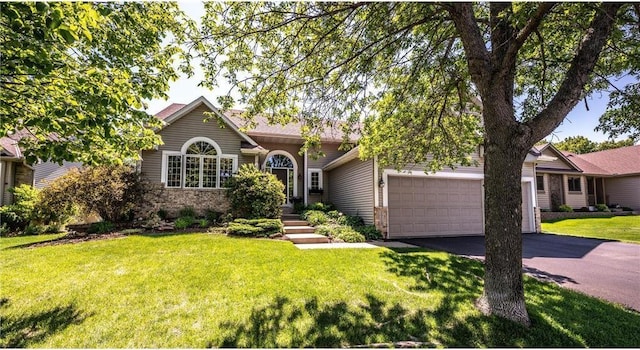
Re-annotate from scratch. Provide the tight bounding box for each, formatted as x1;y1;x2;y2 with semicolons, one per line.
0;2;193;163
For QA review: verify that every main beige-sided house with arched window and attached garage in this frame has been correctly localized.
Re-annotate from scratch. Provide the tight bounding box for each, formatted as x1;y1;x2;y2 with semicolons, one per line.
140;97;539;238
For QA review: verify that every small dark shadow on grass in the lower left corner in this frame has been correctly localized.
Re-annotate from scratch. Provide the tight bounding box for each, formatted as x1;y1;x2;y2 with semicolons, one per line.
0;298;85;348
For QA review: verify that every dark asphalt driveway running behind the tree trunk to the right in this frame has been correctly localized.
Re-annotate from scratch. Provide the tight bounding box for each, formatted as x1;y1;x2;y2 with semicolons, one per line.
402;234;640;311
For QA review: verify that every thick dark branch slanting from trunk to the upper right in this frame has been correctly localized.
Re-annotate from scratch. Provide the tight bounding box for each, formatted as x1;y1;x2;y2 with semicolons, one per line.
524;3;622;142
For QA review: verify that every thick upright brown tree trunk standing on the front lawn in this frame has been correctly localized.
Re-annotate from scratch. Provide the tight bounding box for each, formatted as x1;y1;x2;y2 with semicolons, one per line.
478;102;530;326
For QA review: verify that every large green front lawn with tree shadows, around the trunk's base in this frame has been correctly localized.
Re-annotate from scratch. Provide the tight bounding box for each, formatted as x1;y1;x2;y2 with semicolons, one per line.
0;234;640;348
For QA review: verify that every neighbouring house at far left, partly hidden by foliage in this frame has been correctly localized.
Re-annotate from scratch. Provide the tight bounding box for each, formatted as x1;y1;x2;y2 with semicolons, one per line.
0;133;81;206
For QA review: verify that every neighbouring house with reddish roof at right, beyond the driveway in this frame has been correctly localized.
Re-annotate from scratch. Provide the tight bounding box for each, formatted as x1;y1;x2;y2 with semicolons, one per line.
536;143;640;210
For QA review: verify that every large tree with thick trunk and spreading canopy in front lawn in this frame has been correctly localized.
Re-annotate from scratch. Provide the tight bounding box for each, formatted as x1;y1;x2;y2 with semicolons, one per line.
202;2;640;324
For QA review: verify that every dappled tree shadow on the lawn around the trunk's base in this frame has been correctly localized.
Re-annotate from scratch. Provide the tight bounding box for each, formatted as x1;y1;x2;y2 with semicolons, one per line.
212;250;640;348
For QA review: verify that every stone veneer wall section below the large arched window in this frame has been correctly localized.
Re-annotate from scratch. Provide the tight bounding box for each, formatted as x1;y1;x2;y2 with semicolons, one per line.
138;184;229;218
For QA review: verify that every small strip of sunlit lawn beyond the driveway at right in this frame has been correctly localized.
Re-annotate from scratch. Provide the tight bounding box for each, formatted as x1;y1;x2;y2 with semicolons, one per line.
542;215;640;243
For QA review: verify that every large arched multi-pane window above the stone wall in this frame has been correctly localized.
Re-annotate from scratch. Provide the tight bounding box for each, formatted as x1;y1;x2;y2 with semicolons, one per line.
161;137;238;188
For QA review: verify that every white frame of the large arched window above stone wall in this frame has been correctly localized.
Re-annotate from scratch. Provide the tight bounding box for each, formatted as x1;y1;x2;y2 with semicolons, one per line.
160;137;238;190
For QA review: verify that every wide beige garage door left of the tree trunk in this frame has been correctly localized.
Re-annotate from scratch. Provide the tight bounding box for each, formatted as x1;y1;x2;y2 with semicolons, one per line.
388;176;484;238
